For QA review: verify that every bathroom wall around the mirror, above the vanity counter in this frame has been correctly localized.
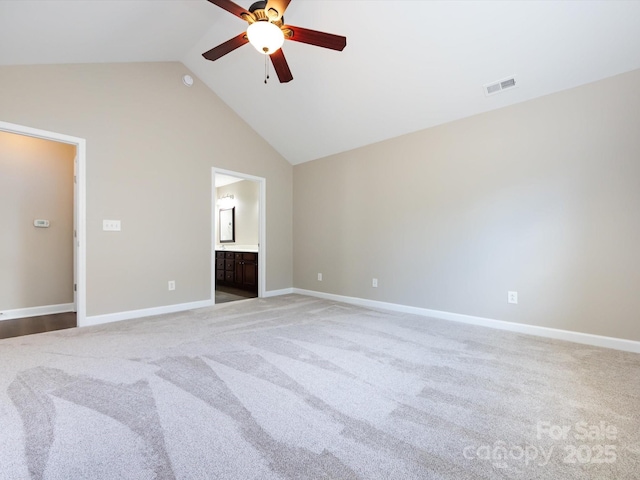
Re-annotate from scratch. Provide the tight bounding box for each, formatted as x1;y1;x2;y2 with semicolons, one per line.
216;180;260;245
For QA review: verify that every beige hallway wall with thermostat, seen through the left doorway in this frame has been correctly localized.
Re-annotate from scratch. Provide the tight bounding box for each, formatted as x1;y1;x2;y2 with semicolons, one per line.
0;131;75;311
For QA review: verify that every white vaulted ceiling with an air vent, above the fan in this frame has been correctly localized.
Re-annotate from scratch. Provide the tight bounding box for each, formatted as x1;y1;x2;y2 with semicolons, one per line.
0;0;640;164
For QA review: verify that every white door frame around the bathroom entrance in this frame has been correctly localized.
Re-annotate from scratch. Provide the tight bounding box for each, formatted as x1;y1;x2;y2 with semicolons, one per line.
211;167;267;304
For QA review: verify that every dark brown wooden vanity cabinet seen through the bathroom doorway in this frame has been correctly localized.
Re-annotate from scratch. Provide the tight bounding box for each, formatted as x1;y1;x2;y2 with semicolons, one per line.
216;250;258;295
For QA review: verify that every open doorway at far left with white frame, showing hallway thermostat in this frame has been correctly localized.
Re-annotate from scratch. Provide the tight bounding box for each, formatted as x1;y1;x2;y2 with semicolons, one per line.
0;122;86;336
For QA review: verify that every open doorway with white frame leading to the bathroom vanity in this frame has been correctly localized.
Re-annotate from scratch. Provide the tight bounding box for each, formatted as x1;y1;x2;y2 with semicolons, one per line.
211;168;266;303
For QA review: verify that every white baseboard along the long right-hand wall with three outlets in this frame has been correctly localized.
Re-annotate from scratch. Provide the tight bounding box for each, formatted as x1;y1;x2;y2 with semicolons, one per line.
293;288;640;353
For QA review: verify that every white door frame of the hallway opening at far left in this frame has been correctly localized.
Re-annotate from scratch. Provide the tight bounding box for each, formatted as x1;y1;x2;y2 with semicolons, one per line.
0;122;87;327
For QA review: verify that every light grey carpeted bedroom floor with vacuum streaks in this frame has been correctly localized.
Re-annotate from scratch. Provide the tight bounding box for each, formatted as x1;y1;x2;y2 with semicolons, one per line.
0;295;640;480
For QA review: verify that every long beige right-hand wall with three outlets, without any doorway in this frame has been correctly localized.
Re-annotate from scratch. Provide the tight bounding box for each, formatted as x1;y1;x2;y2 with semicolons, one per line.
294;71;640;340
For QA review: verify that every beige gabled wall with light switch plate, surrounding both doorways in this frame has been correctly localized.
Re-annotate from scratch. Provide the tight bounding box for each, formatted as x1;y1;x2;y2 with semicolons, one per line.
0;63;292;315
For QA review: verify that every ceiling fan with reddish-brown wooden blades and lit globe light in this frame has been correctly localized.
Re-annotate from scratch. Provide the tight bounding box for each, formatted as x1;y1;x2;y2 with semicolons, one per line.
202;0;347;83
